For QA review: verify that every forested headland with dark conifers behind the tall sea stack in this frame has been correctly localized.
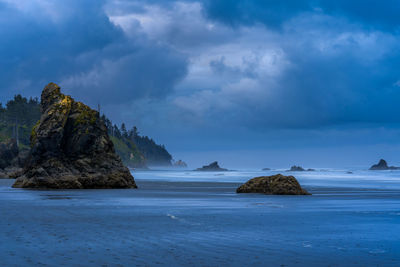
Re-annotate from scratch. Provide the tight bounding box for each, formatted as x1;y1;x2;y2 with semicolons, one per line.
0;95;172;168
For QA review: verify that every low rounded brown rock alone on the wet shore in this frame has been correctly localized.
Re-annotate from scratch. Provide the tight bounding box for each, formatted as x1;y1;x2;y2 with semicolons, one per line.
236;174;310;195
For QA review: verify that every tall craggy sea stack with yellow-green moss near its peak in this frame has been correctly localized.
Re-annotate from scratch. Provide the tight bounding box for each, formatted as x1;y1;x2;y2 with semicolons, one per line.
13;83;137;189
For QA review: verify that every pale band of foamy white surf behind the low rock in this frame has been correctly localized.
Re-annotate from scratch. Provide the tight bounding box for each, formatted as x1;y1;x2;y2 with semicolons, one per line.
132;169;400;190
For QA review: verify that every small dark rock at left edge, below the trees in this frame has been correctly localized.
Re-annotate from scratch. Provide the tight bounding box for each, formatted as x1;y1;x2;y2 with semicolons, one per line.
0;139;28;178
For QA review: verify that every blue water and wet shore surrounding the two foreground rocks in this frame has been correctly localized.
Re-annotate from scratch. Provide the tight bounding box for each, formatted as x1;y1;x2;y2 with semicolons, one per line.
0;169;400;266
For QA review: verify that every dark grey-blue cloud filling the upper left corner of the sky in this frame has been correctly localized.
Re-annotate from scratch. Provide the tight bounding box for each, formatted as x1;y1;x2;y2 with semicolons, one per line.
0;1;122;95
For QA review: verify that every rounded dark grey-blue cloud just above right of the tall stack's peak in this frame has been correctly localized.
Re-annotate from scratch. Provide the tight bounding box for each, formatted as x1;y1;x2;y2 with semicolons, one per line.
63;42;187;104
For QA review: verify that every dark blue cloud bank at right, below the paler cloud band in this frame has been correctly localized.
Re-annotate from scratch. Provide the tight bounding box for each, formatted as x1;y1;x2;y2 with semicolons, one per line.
254;47;400;128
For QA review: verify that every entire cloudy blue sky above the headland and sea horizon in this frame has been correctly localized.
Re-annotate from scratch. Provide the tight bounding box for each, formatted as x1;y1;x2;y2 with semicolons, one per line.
0;0;400;168
